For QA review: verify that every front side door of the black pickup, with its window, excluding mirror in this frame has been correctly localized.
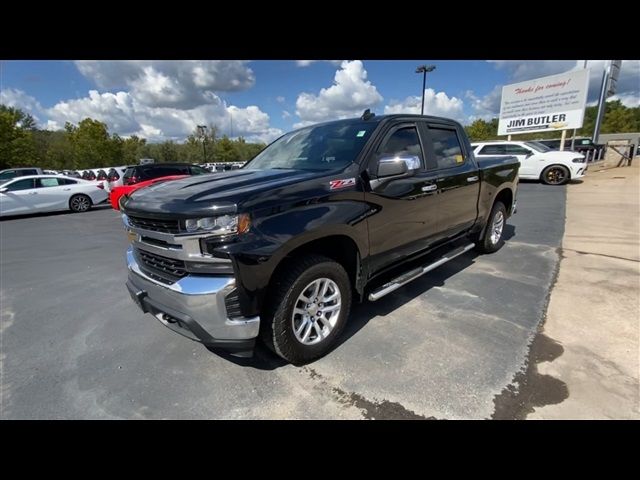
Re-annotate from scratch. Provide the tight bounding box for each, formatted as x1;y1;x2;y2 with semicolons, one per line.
365;122;438;273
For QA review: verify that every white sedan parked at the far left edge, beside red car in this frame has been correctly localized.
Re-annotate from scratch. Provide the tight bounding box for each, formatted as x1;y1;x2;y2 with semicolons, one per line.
0;175;108;217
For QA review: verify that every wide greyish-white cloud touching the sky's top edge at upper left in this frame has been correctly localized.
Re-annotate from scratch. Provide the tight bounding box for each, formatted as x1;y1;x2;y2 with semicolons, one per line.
76;60;255;109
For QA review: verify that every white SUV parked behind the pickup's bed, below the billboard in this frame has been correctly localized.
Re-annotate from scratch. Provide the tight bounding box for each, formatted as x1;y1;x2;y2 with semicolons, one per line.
471;141;587;185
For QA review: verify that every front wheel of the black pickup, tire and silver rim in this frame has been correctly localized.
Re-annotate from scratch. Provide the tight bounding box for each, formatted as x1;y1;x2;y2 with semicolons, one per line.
261;255;352;365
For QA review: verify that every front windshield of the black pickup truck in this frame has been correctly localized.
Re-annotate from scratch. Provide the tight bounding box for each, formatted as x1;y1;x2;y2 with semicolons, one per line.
243;122;377;171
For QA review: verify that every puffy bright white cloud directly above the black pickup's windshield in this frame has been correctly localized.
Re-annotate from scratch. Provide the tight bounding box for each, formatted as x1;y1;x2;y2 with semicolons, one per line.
296;60;382;126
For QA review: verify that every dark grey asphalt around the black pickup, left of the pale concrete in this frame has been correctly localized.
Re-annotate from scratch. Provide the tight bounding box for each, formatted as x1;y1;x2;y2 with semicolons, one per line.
0;183;566;419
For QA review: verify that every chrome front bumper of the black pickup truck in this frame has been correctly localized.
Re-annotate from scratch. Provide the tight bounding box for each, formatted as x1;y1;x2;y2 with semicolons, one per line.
127;247;260;355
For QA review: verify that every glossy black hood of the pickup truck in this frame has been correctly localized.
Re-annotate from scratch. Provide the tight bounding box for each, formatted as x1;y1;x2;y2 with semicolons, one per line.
124;169;323;216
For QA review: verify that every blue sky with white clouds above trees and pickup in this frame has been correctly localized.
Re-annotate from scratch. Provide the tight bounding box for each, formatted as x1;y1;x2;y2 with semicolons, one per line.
0;59;640;143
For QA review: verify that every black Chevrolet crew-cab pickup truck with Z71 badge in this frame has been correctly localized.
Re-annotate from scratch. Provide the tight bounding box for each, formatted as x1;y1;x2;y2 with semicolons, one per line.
123;111;519;364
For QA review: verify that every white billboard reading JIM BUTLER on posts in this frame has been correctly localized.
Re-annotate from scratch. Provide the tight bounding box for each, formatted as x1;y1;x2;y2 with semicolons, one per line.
498;69;589;135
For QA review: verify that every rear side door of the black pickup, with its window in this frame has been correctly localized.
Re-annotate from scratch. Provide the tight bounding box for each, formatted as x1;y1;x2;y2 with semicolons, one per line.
426;123;480;240
